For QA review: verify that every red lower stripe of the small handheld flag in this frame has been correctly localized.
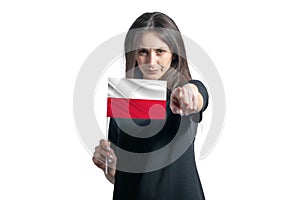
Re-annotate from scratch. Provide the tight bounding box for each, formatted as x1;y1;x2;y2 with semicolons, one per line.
107;97;166;120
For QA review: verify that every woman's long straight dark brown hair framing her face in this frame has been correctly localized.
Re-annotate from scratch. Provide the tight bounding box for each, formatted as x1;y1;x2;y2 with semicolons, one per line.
125;12;191;90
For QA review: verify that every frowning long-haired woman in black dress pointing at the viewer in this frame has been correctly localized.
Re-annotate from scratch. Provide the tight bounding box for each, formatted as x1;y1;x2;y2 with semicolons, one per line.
93;12;208;200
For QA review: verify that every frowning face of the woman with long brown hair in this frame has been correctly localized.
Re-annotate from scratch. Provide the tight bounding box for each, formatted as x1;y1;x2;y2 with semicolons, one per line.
136;32;172;80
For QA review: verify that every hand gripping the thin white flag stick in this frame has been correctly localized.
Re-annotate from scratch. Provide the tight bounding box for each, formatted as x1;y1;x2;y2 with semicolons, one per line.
93;139;117;184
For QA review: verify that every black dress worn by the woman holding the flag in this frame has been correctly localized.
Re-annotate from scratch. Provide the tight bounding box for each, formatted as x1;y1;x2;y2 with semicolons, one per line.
109;80;208;200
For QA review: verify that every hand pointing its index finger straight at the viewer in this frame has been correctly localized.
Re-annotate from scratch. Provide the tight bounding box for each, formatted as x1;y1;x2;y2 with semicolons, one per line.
170;83;203;116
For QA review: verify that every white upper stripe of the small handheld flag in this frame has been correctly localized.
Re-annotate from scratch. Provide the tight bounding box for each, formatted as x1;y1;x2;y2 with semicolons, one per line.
108;78;167;100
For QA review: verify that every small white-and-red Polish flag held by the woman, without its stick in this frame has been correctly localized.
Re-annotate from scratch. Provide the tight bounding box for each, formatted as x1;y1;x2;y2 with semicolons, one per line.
107;78;167;120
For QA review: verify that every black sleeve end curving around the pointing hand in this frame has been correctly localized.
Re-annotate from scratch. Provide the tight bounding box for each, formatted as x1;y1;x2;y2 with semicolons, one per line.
189;80;209;123
